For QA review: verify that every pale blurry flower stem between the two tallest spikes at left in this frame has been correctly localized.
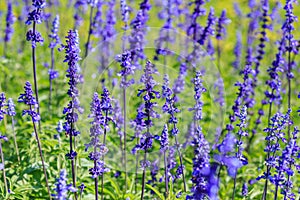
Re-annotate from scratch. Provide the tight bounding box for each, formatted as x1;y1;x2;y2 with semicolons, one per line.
48;15;60;111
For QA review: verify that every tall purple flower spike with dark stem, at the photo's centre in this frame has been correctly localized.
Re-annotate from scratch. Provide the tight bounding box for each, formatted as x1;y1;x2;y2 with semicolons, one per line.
133;60;160;199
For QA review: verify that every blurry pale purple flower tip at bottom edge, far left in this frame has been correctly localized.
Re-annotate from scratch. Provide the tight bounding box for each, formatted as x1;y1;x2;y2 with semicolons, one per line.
51;169;77;200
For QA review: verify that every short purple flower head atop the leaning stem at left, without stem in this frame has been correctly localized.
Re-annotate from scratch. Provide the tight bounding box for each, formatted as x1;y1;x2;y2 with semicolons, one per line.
18;81;41;122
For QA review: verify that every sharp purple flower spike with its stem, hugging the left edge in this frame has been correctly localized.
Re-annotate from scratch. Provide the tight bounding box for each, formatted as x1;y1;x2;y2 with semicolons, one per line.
0;93;8;193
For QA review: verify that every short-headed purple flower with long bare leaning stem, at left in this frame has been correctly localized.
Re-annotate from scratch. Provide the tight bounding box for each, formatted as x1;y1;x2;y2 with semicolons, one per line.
18;81;51;199
